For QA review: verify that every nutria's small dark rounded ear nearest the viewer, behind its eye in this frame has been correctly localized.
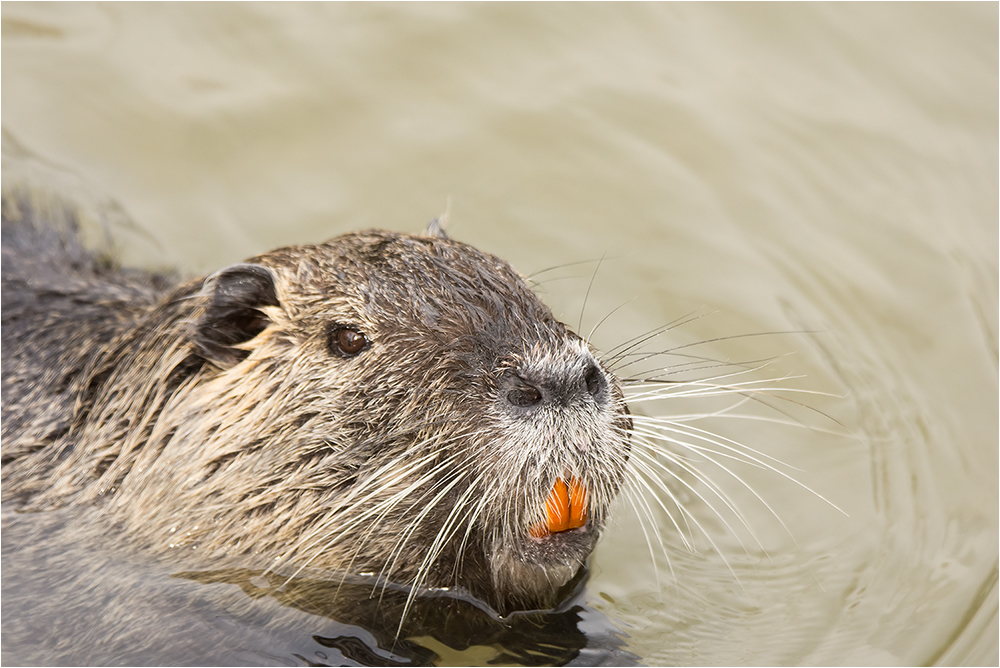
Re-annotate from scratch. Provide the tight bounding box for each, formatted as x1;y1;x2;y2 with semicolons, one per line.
192;264;279;368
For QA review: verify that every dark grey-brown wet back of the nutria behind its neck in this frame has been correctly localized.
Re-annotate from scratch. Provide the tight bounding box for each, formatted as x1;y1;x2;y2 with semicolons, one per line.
0;204;171;464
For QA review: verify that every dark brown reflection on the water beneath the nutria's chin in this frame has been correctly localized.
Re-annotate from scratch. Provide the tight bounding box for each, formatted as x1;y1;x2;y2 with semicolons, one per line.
175;568;634;666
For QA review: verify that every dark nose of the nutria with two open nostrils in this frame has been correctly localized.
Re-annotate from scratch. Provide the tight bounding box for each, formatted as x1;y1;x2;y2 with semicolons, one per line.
503;362;608;409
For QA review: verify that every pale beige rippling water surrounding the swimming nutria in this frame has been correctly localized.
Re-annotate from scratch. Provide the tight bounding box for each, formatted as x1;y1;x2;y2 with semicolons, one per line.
2;3;998;664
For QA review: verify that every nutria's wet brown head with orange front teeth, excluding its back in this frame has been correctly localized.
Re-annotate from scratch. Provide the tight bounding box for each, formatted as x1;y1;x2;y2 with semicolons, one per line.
82;231;631;610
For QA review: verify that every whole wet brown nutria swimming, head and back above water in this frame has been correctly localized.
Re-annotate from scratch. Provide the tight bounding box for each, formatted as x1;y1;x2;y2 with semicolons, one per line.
2;199;631;611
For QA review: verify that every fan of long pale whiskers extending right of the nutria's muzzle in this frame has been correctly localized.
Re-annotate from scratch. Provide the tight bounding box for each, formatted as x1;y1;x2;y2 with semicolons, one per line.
601;306;850;588
